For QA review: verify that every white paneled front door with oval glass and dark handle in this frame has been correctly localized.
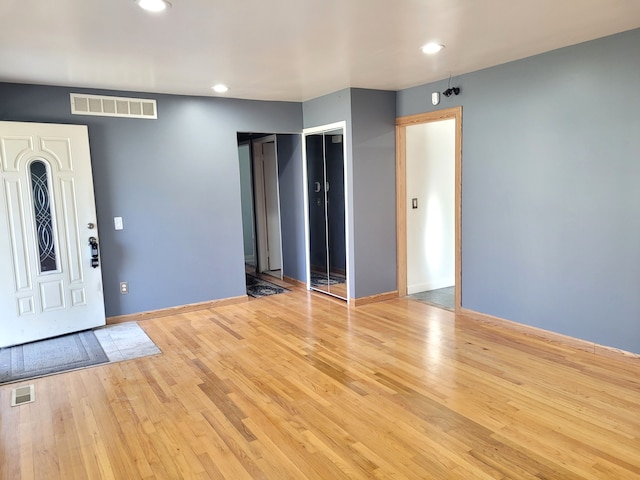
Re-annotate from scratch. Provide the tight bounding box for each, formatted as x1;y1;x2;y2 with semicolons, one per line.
0;122;105;347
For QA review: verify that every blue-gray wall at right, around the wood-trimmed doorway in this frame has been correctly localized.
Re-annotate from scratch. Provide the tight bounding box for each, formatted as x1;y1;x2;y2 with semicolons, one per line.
397;30;640;353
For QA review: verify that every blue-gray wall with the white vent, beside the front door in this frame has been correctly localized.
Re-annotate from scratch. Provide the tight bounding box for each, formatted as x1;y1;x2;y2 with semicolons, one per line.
0;84;302;316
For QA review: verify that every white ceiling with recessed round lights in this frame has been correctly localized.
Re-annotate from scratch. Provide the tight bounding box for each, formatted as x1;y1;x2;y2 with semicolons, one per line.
0;0;640;101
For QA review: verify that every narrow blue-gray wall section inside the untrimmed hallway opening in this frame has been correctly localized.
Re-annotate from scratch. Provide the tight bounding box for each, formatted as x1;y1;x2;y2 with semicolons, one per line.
277;134;307;282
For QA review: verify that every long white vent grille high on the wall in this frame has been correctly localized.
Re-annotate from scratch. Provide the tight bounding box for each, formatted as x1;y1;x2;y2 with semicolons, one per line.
70;93;158;119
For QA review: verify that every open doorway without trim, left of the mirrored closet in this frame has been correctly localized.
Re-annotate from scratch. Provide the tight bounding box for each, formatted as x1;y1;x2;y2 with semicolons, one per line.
237;133;307;296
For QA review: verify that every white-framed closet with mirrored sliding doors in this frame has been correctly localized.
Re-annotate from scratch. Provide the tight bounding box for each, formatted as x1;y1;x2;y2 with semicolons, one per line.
303;122;349;300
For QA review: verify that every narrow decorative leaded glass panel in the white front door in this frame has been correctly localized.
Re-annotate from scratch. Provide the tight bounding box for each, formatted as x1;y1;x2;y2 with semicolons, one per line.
30;161;58;272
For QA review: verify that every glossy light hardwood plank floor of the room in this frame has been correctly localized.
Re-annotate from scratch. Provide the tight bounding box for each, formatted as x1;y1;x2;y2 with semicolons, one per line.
0;290;640;480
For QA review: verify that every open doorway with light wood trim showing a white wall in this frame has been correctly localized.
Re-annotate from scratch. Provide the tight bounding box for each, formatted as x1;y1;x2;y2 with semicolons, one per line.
396;107;462;311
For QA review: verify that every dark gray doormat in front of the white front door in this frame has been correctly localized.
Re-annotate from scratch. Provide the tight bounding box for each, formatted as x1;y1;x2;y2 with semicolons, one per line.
0;330;109;384
